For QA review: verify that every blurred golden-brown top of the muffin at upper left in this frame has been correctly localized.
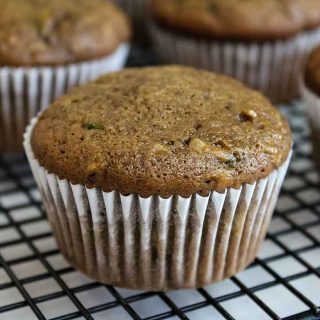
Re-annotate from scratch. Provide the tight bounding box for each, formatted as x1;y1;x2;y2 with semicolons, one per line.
0;0;130;66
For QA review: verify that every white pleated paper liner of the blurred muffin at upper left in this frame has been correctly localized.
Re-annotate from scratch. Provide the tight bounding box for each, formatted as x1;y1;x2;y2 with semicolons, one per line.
0;44;129;152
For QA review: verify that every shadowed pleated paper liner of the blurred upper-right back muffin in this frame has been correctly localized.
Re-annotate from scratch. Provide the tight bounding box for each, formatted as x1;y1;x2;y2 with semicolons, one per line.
150;22;320;102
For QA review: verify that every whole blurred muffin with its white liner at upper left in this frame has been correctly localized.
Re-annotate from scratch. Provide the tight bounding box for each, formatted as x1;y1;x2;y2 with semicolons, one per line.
0;0;130;152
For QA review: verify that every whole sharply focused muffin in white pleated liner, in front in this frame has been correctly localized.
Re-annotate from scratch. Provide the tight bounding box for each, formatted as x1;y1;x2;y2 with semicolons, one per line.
24;66;292;291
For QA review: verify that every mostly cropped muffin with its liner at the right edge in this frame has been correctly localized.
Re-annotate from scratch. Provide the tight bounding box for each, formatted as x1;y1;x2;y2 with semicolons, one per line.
301;47;320;169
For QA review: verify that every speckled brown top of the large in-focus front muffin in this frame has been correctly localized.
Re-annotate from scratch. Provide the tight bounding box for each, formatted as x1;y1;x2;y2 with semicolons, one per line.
31;66;291;197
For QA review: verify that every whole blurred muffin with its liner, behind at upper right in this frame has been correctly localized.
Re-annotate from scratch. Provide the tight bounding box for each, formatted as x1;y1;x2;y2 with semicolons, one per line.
150;0;320;102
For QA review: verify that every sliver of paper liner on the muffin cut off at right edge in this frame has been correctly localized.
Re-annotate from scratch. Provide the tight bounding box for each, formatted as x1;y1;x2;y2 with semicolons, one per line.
301;81;320;170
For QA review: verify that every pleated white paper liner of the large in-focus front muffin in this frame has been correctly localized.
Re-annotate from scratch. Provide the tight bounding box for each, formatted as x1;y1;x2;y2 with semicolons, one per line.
24;118;291;291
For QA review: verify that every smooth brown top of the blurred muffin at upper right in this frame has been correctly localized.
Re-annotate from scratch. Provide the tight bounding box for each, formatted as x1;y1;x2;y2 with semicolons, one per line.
152;0;320;40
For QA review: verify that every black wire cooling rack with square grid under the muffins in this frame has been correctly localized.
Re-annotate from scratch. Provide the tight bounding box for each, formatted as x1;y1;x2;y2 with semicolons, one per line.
0;48;320;320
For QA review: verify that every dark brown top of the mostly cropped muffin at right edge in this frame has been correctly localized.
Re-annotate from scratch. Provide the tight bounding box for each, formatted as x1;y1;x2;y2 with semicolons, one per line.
305;47;320;95
